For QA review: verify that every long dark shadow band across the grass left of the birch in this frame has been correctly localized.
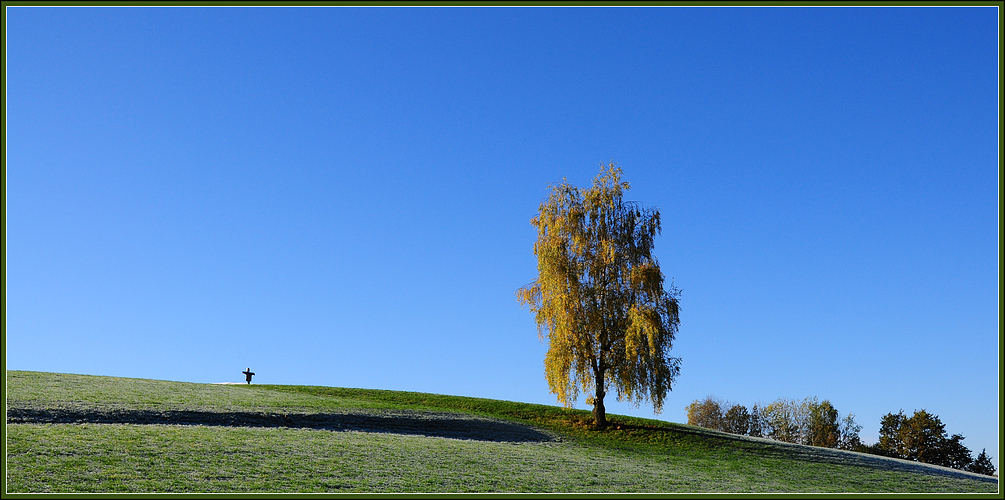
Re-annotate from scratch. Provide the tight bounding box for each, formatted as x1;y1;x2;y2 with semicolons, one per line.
7;408;557;443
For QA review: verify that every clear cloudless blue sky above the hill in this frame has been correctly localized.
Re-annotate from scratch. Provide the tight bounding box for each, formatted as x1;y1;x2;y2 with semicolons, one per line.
5;7;1001;463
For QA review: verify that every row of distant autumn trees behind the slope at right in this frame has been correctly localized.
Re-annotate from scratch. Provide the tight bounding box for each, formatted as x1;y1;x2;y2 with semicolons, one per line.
686;396;996;476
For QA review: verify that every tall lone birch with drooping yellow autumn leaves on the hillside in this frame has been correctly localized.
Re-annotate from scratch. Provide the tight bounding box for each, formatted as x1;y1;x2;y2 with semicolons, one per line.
517;164;680;429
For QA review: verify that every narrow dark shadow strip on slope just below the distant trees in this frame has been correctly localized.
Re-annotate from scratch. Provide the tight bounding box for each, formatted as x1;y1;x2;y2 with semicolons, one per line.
622;425;998;483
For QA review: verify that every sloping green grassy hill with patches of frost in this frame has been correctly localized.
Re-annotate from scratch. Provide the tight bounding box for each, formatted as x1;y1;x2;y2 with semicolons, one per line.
6;371;999;494
